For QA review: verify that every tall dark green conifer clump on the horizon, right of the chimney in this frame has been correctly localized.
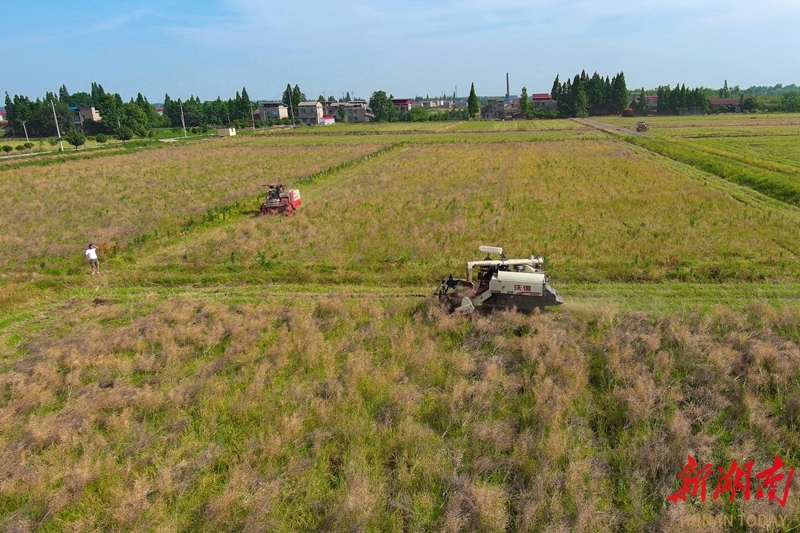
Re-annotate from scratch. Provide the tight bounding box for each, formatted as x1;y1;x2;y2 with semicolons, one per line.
550;70;628;118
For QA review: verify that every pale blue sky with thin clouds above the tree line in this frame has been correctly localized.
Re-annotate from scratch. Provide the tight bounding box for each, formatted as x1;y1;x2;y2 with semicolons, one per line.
6;0;800;102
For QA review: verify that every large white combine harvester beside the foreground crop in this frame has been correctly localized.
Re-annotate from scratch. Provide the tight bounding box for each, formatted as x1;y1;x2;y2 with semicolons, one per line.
435;246;564;313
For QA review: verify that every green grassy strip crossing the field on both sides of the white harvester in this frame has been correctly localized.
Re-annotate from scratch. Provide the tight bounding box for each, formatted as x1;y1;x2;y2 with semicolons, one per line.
13;274;800;314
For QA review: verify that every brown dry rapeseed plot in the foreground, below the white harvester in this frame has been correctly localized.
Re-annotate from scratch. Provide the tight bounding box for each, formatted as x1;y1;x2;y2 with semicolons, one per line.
0;297;800;531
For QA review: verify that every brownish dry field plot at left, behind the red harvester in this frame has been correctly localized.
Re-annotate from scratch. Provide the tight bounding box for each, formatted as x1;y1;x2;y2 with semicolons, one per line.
0;139;382;270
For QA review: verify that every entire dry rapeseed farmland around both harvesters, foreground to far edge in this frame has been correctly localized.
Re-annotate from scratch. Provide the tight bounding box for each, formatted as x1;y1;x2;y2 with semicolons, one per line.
0;117;800;532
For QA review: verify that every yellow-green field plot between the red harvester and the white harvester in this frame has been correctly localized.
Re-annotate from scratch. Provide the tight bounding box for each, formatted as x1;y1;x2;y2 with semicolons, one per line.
139;140;800;285
